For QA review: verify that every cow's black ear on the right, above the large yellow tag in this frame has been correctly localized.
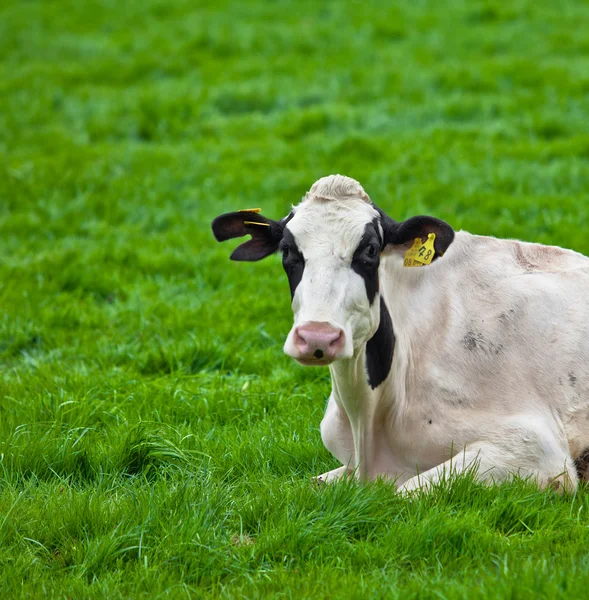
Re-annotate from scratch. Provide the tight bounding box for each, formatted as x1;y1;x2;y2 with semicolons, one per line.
383;215;454;260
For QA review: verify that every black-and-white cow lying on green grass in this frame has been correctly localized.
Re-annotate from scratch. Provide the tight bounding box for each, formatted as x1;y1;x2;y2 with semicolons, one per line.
212;175;589;493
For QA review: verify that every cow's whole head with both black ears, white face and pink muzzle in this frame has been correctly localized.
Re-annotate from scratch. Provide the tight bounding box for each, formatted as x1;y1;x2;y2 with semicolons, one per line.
212;175;454;365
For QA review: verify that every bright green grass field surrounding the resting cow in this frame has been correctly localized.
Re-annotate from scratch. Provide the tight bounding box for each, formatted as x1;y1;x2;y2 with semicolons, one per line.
0;0;589;599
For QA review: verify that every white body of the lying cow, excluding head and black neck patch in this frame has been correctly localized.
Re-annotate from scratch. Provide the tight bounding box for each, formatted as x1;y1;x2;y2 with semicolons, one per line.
321;232;589;488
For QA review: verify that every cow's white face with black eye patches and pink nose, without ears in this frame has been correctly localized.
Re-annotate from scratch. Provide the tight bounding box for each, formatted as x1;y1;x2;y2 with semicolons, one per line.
278;195;383;365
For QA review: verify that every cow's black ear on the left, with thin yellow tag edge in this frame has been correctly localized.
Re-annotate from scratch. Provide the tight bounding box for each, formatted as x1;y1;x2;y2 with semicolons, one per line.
212;209;291;261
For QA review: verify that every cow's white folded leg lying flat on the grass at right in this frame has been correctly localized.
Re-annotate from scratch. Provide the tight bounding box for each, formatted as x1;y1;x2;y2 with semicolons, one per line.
398;444;578;493
